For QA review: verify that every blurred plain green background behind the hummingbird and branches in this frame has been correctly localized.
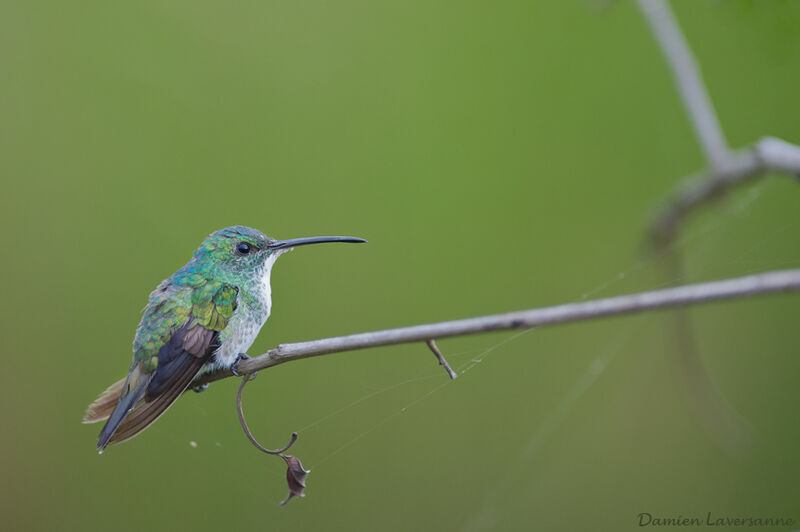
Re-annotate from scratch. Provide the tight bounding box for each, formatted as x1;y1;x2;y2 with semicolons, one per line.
0;0;800;531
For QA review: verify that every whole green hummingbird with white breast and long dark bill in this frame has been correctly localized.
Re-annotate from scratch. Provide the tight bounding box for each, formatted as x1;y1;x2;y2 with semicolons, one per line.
83;225;366;453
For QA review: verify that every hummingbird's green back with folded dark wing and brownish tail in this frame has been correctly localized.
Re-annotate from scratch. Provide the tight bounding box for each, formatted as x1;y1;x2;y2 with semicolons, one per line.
94;274;239;450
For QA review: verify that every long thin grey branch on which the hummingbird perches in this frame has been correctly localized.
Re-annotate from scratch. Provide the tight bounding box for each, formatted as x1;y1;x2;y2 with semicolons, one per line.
191;269;800;382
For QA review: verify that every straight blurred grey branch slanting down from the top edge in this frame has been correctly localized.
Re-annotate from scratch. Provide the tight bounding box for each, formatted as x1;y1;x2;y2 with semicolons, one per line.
638;0;729;171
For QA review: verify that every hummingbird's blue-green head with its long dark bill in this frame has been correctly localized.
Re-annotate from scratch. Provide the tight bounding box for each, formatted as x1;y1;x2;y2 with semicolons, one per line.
193;225;366;272
